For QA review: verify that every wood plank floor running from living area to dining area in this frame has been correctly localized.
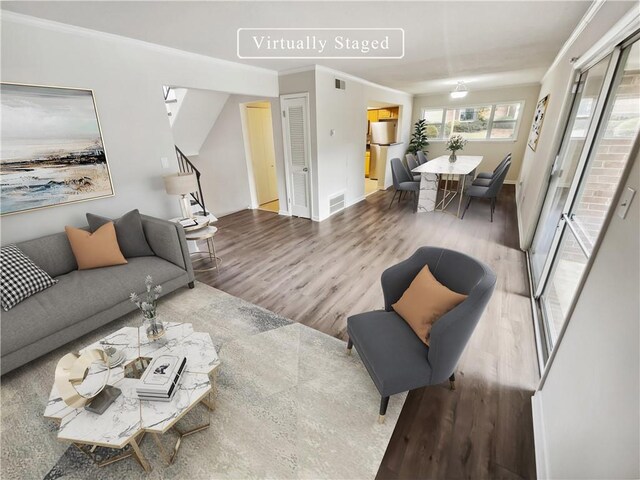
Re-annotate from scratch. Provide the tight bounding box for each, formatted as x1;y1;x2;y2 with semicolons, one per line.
197;186;538;479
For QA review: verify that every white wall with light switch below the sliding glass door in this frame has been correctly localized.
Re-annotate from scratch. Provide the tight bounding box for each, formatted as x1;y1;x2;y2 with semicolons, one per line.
533;149;640;479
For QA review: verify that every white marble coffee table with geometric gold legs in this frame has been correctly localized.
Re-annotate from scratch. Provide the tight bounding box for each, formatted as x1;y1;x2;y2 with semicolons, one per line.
44;323;220;471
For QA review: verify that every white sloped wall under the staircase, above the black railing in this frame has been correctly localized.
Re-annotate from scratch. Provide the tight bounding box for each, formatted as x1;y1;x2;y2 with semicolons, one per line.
170;88;229;157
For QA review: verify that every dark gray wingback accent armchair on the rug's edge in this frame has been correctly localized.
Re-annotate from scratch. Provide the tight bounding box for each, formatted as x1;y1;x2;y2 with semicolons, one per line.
347;247;496;423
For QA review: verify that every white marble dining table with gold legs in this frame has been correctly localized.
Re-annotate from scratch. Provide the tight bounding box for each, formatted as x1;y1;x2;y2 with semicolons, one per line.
411;155;483;217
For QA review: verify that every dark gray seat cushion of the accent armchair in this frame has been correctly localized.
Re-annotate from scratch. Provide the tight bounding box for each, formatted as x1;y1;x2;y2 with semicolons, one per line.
347;310;431;397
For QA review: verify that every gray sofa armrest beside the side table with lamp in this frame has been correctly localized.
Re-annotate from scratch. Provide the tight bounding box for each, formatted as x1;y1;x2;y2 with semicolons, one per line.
140;215;195;286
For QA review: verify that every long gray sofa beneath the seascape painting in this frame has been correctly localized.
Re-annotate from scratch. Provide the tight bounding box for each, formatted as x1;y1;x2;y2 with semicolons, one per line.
0;215;194;374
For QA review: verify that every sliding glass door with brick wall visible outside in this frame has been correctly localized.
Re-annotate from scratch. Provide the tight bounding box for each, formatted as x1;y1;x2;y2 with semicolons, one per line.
530;35;640;358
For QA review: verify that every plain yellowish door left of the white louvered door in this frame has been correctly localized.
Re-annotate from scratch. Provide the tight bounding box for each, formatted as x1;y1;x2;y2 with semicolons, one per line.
247;106;278;205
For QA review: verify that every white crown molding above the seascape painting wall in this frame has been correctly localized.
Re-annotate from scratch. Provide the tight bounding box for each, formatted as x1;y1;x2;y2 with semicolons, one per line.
0;10;278;75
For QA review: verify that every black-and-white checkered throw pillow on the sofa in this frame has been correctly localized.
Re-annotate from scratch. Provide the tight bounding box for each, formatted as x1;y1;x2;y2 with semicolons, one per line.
0;245;58;312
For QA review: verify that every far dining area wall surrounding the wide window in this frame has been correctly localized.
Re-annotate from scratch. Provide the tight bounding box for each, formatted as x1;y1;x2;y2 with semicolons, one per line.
413;84;540;183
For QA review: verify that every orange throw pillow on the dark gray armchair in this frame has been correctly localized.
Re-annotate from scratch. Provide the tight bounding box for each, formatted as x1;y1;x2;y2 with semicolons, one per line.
391;265;467;345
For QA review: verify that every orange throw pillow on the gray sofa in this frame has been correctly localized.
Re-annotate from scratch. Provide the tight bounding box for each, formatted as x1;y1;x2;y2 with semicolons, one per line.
64;222;127;270
